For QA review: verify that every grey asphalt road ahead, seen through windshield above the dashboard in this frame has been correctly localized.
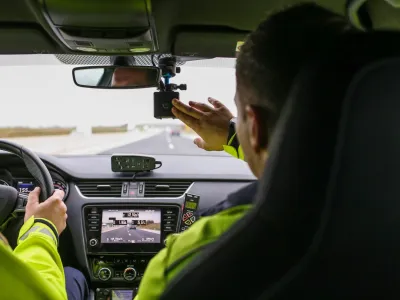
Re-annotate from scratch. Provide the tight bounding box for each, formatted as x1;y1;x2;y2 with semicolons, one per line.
100;132;228;156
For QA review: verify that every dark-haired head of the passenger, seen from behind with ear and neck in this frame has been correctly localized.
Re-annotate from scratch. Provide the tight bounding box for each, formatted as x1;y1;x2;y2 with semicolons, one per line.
235;4;350;177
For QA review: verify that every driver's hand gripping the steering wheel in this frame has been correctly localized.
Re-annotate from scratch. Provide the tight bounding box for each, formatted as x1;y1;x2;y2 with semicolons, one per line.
24;187;67;234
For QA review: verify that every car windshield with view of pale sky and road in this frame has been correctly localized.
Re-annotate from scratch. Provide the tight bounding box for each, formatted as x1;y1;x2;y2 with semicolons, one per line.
0;55;236;156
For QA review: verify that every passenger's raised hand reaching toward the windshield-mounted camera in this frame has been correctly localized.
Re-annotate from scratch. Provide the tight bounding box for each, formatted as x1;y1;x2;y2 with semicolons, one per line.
172;98;233;151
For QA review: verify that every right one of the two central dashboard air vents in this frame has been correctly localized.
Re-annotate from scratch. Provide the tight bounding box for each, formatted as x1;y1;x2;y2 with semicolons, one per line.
144;181;192;198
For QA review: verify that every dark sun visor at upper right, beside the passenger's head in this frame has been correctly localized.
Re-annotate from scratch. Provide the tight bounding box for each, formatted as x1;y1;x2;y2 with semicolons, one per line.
172;28;249;58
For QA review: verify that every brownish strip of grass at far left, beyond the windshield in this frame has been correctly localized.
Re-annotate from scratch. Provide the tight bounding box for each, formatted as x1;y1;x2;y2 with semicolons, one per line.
0;127;76;138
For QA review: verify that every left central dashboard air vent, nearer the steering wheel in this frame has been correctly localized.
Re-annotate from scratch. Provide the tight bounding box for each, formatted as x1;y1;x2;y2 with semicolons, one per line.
77;180;122;198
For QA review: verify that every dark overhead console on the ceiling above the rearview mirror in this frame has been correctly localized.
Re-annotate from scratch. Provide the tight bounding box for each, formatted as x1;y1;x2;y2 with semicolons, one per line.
41;0;158;55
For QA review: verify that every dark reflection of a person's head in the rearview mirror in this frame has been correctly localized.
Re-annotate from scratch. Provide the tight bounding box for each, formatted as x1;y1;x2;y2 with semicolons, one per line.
111;67;150;87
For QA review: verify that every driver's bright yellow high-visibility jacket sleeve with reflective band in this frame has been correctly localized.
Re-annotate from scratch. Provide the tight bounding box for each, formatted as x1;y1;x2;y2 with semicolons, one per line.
0;217;67;300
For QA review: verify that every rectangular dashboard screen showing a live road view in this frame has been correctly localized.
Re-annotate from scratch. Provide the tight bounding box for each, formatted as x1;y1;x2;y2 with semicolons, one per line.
101;209;161;244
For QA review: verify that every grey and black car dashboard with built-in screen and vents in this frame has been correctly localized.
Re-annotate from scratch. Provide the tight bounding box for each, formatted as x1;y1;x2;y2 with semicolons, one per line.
0;152;256;300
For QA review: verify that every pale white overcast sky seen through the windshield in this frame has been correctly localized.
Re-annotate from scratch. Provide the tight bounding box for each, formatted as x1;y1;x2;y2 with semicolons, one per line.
0;55;236;127
